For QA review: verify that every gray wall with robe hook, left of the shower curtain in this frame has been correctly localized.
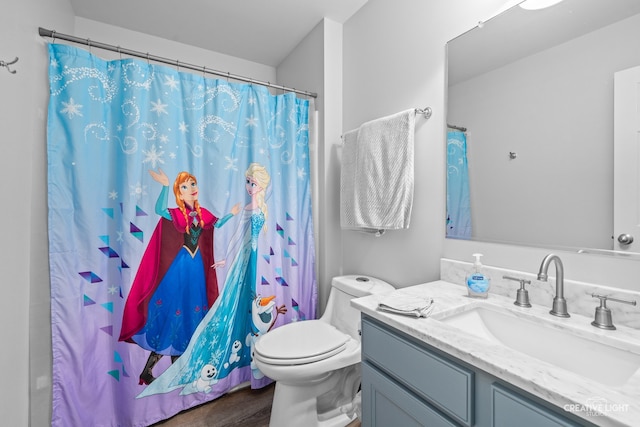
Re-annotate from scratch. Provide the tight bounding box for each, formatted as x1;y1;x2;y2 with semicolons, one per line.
0;0;73;426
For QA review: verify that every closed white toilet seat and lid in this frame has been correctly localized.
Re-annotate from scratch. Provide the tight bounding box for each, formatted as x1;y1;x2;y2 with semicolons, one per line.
254;320;350;365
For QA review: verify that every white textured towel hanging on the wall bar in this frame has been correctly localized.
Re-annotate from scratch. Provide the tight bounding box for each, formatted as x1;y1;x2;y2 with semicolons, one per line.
340;109;415;230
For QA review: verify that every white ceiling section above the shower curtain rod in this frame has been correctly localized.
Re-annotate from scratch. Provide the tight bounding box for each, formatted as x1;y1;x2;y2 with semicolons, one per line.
70;0;367;67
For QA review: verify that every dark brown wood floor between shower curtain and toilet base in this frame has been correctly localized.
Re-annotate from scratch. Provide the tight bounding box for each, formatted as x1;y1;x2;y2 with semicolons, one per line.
153;383;360;427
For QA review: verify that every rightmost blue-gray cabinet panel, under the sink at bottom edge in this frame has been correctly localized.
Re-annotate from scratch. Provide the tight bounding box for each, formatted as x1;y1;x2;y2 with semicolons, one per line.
491;383;579;427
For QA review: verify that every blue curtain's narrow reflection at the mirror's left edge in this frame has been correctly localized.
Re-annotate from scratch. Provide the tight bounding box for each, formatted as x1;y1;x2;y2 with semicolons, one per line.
446;130;471;239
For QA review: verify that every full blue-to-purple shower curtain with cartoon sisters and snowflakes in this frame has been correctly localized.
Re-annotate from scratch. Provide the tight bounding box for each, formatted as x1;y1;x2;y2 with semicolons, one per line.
47;44;317;427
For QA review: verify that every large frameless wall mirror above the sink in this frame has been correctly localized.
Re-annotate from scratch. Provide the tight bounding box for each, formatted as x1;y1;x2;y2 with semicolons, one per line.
447;0;640;259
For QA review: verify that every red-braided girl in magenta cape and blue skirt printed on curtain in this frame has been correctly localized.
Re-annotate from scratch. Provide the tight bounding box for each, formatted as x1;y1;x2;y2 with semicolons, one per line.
120;169;240;385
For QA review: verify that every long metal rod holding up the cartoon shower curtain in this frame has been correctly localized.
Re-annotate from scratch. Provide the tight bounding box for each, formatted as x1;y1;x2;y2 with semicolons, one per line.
38;27;318;98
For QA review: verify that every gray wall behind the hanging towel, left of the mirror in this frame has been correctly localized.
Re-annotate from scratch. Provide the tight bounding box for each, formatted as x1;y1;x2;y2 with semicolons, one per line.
335;0;504;287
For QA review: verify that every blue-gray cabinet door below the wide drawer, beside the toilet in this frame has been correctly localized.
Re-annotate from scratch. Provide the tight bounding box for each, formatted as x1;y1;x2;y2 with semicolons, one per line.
362;362;457;427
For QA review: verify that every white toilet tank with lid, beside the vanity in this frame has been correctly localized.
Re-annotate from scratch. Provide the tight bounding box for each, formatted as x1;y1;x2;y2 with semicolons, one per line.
320;275;395;340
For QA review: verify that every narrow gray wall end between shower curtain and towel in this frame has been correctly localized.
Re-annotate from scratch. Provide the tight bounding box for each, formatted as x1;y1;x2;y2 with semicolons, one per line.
277;19;342;314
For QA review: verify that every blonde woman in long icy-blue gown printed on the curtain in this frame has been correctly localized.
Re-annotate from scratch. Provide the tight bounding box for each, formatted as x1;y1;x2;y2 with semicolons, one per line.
138;163;283;397
